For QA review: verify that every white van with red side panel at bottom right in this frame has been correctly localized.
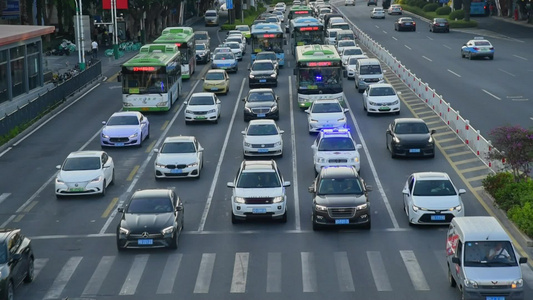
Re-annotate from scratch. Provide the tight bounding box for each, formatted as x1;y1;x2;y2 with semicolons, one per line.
446;217;527;300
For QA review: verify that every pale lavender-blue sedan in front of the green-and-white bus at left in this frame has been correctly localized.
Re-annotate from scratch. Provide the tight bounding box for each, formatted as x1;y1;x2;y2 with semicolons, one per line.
100;111;150;147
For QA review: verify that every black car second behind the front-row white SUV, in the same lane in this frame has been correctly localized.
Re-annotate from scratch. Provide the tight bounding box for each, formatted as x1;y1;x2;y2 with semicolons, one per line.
242;89;279;122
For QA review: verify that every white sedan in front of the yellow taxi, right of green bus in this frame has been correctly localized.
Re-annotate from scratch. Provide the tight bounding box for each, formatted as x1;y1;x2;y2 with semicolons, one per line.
185;92;220;124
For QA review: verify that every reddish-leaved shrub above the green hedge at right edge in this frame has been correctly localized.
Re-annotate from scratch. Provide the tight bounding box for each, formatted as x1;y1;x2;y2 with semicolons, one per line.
488;125;533;182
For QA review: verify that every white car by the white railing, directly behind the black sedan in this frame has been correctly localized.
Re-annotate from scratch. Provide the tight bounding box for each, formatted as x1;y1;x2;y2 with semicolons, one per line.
363;83;401;115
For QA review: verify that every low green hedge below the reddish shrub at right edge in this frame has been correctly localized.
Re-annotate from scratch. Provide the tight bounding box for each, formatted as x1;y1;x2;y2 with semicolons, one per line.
483;172;533;237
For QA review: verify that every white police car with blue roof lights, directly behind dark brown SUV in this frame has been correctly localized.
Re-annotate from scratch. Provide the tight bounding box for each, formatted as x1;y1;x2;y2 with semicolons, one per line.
311;128;362;175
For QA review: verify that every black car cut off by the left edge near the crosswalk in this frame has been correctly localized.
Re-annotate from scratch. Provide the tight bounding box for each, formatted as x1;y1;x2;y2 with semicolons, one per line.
0;229;34;300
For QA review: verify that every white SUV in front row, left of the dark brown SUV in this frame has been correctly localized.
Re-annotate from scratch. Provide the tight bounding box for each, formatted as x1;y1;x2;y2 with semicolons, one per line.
227;160;291;224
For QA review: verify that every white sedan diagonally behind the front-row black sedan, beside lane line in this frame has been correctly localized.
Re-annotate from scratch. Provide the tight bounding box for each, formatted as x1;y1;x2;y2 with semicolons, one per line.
154;136;204;180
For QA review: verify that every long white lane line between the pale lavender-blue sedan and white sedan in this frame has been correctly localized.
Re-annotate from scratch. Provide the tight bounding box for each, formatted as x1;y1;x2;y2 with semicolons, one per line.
100;80;201;234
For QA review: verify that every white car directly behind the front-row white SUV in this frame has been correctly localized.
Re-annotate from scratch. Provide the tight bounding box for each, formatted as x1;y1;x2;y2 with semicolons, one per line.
242;119;283;157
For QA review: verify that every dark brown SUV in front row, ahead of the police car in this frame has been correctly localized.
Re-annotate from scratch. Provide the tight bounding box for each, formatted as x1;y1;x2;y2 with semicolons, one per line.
309;167;371;230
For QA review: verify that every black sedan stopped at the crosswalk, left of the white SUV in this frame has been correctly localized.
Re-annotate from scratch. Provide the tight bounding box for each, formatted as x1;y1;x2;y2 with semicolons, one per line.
117;189;184;251
